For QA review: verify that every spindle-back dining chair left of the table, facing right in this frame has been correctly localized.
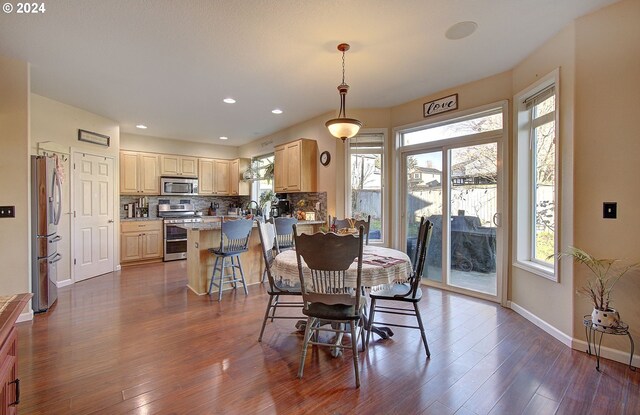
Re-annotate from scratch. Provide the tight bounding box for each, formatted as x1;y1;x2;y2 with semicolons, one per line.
258;222;304;342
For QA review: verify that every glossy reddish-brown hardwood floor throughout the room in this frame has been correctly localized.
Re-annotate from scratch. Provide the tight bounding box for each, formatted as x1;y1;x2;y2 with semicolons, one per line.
18;261;640;415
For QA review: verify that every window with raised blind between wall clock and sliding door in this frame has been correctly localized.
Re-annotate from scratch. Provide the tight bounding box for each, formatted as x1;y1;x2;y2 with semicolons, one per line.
345;133;384;243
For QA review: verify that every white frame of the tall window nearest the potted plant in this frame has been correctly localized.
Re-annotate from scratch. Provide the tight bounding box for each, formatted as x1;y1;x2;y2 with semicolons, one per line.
513;69;561;282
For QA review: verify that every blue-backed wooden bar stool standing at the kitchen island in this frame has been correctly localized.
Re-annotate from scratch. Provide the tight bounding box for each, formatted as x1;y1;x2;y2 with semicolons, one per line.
208;219;253;301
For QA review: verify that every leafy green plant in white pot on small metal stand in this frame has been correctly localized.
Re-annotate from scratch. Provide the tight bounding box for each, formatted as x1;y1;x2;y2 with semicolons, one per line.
559;246;640;327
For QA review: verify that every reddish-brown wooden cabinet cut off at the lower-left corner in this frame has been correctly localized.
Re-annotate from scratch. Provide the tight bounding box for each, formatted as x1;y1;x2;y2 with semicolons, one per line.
0;294;32;415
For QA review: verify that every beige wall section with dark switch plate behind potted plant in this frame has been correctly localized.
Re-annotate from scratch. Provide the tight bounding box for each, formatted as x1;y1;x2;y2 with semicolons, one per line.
573;0;640;358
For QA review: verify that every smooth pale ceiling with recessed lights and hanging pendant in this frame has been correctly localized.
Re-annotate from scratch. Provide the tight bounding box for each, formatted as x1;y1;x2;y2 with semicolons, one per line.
0;0;616;146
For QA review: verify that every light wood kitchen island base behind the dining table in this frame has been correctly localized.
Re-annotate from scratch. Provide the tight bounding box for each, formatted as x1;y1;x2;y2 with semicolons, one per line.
180;220;323;295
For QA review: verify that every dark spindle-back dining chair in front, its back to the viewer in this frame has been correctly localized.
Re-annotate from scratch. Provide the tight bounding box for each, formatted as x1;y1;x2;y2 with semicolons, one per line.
294;225;365;387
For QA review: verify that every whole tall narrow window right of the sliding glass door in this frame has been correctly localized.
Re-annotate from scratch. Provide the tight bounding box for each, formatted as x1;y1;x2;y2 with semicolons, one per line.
514;71;558;279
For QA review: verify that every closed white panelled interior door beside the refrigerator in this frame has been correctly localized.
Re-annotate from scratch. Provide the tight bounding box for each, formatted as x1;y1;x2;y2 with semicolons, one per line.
73;153;114;282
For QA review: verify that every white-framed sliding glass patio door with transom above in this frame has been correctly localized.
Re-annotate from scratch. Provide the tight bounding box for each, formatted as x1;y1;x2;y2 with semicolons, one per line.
400;105;503;300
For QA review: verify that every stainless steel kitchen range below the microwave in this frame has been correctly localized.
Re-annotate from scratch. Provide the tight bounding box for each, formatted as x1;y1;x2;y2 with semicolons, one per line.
158;203;202;261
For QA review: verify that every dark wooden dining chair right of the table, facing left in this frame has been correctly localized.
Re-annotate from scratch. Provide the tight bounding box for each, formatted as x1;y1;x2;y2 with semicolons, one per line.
366;218;433;358
